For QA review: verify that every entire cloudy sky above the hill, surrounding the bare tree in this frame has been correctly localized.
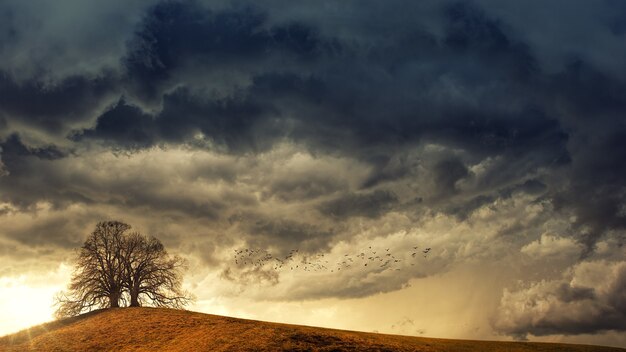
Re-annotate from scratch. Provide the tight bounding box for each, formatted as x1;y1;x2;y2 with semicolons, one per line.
0;0;626;347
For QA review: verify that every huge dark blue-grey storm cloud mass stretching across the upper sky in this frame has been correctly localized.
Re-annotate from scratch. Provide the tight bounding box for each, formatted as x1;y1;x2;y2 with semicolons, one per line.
0;1;626;248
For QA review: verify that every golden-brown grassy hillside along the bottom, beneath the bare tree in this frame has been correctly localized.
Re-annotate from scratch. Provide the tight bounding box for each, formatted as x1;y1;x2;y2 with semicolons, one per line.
0;308;626;352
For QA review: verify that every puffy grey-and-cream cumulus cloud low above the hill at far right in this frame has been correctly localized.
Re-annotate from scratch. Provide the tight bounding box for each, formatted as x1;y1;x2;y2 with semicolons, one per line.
494;261;626;338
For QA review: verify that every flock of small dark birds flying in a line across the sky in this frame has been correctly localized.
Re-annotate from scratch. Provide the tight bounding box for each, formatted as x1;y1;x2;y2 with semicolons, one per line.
233;246;431;272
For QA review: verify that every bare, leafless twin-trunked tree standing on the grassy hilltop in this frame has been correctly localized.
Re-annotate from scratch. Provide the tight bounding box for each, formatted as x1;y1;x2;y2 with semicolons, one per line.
56;221;191;317
